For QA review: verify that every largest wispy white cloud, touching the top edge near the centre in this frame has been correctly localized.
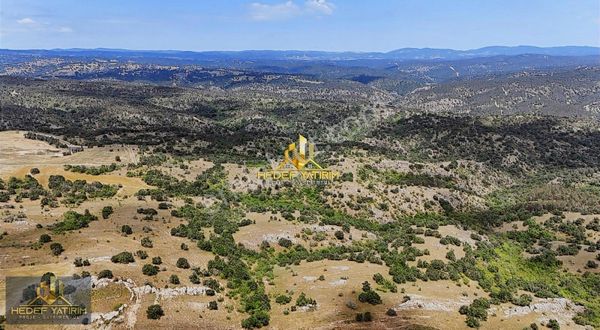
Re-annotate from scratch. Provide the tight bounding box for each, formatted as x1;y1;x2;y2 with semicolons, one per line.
250;0;335;21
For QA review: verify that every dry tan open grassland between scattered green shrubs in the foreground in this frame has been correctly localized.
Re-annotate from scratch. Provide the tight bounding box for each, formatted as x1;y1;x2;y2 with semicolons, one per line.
0;132;598;329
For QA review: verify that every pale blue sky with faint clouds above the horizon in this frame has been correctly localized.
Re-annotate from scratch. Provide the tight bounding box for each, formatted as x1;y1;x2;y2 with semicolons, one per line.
0;0;600;51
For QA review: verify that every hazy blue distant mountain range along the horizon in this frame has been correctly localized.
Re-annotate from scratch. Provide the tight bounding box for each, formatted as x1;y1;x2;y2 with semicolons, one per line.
0;46;600;61
